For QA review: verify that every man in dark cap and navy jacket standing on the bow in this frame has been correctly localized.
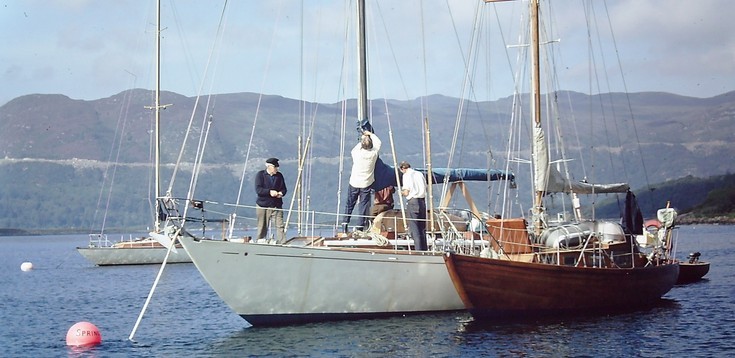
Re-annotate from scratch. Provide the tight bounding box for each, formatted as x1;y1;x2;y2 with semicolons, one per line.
255;158;287;244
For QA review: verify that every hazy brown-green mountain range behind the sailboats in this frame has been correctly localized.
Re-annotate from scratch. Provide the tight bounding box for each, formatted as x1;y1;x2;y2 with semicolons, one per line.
0;89;735;231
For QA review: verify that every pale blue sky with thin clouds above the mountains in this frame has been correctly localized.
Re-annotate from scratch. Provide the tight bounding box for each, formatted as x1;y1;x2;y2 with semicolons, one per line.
0;0;735;105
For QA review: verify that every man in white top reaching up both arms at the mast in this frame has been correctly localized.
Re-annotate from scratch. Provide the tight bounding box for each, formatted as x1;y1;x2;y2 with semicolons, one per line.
342;131;381;232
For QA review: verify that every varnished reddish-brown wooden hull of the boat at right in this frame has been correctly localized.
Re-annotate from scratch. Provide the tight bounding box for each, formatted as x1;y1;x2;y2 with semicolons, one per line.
444;254;679;318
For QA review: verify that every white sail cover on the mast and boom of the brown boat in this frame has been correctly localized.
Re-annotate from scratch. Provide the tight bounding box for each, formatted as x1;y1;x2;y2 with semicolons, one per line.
533;127;630;194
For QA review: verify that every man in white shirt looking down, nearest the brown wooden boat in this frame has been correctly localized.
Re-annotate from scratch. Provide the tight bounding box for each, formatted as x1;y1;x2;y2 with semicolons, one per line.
398;161;429;251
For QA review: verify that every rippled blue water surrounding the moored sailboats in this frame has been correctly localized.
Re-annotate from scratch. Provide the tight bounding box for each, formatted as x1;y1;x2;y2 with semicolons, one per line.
0;226;735;357
